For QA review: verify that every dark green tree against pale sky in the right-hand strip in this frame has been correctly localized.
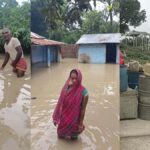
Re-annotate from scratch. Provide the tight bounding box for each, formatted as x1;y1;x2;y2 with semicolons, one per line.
120;0;146;33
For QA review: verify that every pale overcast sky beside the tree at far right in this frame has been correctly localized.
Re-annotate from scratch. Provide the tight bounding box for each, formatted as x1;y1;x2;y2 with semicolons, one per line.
131;0;150;33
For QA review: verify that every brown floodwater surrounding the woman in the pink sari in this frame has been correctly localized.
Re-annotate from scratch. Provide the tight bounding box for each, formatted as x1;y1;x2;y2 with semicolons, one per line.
31;59;120;150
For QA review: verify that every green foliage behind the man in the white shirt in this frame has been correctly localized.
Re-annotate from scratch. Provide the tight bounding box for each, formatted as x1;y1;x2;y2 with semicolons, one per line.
0;0;30;53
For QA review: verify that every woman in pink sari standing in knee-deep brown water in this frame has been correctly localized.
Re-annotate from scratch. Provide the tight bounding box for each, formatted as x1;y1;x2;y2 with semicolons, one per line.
53;69;88;140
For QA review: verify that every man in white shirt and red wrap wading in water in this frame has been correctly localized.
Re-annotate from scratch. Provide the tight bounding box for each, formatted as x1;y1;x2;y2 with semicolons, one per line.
0;28;27;77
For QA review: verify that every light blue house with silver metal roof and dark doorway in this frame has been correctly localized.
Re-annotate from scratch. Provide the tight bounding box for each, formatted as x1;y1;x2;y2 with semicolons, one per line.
76;33;121;64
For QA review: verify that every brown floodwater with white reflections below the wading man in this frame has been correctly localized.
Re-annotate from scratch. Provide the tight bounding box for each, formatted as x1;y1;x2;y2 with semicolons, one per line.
0;56;31;150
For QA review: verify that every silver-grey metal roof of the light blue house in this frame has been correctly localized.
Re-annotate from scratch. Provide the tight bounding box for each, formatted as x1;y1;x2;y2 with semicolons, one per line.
76;33;121;44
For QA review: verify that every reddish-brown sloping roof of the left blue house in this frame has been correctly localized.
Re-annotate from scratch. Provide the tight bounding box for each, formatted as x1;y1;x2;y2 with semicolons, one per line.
30;32;64;46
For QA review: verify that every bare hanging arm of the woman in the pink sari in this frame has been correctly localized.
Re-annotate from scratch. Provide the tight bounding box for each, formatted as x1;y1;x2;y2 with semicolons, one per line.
79;95;89;125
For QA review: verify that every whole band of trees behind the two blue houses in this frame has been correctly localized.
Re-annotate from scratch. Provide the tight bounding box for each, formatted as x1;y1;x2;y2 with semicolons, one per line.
31;0;119;44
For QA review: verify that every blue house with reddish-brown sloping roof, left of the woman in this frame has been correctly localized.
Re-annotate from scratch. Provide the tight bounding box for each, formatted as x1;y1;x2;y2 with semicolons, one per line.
31;32;63;67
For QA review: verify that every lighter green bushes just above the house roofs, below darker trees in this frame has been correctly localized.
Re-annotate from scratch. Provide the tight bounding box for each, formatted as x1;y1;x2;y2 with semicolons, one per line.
49;11;119;44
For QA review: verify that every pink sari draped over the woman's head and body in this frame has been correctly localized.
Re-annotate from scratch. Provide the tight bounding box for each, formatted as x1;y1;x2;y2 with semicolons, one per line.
53;69;84;138
